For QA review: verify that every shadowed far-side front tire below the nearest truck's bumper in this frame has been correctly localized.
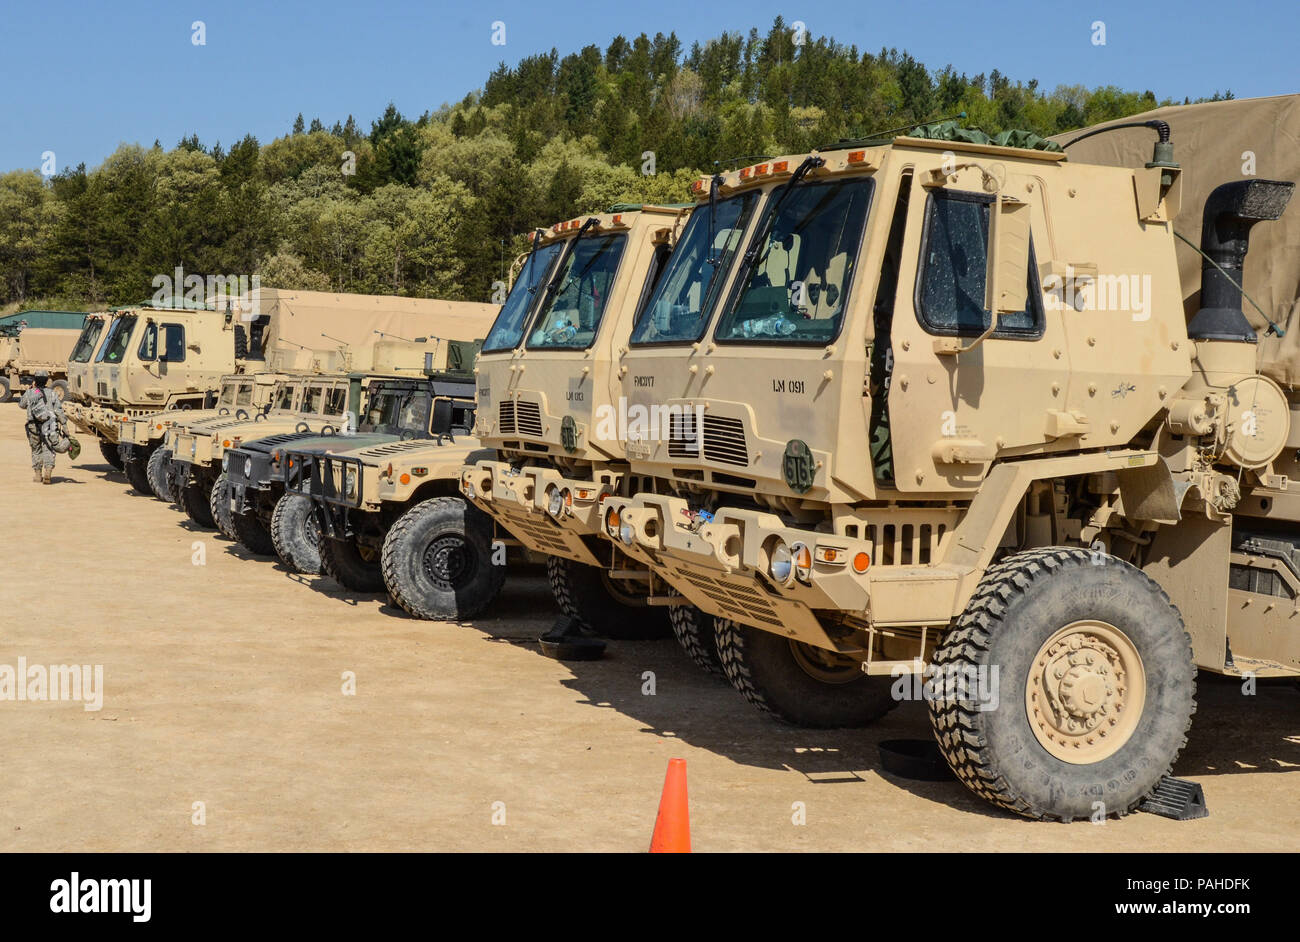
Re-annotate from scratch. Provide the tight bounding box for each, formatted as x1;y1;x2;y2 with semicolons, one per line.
715;618;898;729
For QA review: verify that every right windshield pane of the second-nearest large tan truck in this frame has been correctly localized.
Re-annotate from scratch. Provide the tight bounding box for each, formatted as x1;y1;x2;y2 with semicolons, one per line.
528;233;628;350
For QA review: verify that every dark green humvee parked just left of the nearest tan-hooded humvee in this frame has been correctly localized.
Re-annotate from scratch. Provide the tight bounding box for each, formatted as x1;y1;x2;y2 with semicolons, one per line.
221;342;475;574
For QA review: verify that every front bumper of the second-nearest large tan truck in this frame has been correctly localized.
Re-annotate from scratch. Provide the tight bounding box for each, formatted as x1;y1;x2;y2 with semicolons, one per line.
460;461;616;568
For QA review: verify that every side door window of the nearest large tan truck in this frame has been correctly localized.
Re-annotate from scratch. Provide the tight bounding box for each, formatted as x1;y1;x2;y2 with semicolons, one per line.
917;190;1044;339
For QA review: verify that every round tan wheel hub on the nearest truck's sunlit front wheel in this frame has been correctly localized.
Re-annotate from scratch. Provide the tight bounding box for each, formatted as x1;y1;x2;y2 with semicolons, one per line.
1024;621;1147;765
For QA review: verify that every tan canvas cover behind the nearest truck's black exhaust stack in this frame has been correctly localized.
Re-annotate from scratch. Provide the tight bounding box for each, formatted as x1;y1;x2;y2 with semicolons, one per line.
1053;95;1300;385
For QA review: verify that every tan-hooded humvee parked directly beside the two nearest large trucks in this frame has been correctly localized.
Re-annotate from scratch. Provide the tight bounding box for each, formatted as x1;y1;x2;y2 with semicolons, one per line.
277;374;514;620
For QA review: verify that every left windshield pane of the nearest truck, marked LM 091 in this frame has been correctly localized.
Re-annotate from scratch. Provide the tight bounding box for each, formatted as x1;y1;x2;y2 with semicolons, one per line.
632;190;759;343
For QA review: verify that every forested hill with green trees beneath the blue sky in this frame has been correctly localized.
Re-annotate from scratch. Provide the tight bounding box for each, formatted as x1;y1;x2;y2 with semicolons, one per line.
0;19;1216;309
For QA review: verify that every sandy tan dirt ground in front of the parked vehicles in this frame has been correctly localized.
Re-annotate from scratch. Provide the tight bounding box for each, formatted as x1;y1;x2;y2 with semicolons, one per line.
0;404;1300;851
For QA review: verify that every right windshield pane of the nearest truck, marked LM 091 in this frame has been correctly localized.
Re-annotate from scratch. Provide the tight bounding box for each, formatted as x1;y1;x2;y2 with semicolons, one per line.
715;178;872;343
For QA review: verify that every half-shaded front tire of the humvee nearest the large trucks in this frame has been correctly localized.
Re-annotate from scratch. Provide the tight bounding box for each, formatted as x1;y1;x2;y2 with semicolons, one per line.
382;498;506;621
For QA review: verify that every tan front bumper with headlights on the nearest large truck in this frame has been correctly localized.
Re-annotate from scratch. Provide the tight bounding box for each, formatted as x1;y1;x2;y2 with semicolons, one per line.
601;494;967;650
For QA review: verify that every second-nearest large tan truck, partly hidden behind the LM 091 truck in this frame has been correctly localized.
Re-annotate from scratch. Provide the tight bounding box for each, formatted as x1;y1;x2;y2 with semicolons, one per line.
460;205;725;641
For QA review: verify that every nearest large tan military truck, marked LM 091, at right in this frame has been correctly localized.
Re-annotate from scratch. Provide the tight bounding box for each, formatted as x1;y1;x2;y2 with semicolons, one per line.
601;122;1300;820
